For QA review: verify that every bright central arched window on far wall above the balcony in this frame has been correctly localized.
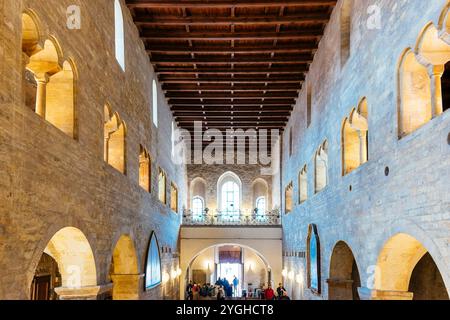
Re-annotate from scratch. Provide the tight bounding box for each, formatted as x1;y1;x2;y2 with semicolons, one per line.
217;172;241;216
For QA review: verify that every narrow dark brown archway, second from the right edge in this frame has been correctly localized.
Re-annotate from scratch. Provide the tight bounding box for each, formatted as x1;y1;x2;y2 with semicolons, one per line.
327;241;361;300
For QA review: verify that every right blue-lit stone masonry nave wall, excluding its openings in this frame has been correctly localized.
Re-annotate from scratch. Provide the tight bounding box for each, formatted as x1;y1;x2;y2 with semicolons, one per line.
282;0;450;299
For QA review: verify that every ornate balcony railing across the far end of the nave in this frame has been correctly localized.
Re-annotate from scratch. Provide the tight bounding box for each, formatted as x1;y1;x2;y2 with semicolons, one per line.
183;210;281;226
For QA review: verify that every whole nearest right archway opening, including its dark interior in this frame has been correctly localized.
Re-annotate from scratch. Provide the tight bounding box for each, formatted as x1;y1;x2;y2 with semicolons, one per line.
375;233;449;300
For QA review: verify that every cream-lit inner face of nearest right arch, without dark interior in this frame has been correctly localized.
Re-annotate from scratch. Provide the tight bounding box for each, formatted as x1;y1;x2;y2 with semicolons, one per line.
374;233;448;299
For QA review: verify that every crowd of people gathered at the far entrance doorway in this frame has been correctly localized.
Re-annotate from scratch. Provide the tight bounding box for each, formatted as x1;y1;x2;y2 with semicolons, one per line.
186;277;290;300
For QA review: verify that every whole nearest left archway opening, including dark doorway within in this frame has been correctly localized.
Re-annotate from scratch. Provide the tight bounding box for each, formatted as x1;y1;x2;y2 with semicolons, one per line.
30;227;97;299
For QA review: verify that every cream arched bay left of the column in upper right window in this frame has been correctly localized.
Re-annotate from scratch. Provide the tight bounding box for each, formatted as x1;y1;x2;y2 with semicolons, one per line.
397;49;432;138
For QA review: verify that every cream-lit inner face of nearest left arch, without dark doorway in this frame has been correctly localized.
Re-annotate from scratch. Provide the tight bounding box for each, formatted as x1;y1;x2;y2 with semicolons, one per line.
31;227;98;298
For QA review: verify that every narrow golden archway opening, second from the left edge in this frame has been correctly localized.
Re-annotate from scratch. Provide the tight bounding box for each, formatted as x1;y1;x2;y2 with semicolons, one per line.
110;235;141;300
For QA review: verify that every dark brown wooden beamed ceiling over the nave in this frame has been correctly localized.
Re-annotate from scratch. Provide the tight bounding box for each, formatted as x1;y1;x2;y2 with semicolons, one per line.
126;0;337;150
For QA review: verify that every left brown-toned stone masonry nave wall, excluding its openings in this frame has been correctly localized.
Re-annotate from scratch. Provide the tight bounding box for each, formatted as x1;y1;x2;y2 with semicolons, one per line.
0;0;186;299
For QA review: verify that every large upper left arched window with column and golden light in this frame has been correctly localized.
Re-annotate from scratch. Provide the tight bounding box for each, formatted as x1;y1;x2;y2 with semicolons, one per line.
22;12;77;138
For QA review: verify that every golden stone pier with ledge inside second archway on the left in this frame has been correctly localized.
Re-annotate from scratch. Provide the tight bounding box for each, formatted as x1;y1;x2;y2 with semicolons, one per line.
111;274;144;300
